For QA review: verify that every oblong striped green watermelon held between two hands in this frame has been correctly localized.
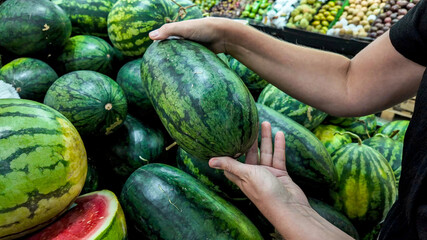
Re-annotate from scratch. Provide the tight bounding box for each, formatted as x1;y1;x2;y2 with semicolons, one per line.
141;40;258;159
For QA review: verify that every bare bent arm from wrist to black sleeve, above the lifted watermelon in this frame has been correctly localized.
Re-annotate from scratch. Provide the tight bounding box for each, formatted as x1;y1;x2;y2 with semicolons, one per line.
223;24;424;116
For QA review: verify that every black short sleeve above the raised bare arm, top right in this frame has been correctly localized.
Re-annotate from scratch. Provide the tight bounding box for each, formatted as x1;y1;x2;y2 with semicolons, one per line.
390;0;427;66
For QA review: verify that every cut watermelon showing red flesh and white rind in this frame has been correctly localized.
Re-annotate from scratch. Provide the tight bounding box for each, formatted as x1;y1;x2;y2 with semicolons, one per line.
25;190;126;240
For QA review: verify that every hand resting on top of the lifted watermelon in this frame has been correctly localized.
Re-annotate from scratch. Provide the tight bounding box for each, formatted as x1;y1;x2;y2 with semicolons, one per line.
149;18;240;53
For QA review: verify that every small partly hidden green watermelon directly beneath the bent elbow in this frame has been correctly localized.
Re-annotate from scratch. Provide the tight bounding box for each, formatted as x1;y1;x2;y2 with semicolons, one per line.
327;114;377;139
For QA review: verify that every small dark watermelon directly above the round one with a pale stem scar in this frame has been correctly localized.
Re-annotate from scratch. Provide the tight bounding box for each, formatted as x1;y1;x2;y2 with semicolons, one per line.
55;35;115;76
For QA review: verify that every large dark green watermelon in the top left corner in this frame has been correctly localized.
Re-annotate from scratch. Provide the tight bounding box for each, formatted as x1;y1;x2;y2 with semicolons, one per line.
0;0;71;58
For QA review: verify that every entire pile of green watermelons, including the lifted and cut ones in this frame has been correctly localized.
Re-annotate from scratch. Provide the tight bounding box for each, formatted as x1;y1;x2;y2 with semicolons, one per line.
0;0;409;239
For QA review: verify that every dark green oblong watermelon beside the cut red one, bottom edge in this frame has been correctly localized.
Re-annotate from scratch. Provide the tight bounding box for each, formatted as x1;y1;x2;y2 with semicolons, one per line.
120;163;262;240
